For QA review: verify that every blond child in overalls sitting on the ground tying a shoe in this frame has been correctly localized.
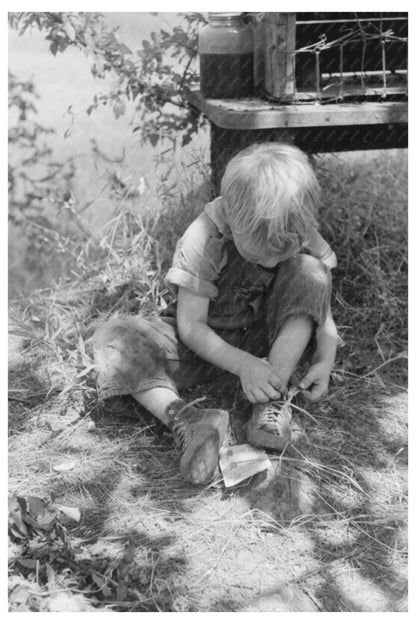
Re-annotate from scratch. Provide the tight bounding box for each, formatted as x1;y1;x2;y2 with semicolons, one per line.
94;143;337;484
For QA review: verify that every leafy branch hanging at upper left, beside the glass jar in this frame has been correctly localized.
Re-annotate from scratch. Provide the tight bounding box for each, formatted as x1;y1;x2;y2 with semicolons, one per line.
9;12;206;146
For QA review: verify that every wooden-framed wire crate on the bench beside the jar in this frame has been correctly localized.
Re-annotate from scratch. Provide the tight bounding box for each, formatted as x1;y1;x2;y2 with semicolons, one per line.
262;12;408;102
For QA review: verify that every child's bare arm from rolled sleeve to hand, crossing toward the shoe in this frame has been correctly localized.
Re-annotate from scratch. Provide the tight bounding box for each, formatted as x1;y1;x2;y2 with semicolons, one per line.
177;287;285;403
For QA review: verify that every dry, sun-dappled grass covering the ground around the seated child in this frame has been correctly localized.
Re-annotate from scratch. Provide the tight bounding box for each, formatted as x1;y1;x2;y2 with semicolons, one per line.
9;151;407;612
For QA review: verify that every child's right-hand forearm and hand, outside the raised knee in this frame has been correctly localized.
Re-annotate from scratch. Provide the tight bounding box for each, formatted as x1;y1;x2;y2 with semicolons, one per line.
299;307;337;401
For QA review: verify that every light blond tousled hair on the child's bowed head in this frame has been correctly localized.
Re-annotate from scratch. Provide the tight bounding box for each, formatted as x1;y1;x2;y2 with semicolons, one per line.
221;143;320;250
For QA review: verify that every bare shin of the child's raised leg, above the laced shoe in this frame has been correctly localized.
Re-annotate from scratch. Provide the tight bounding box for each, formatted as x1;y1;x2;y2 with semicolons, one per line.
268;314;314;386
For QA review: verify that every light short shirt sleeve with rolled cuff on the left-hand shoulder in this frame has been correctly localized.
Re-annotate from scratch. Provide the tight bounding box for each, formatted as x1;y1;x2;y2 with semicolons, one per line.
165;214;226;299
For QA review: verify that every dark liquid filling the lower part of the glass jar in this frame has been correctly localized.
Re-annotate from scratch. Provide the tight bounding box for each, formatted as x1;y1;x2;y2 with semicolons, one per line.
199;52;254;98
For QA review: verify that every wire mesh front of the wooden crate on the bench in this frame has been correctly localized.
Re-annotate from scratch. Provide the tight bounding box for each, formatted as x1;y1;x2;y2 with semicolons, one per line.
262;13;408;101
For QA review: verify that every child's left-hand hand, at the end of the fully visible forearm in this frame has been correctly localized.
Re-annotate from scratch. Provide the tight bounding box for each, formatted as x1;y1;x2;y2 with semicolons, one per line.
238;353;287;403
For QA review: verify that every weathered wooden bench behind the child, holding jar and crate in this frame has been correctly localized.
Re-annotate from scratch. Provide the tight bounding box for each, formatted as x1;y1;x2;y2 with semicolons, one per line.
186;91;408;187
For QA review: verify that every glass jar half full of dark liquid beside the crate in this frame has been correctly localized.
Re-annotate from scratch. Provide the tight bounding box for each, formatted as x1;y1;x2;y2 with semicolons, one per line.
198;13;253;98
